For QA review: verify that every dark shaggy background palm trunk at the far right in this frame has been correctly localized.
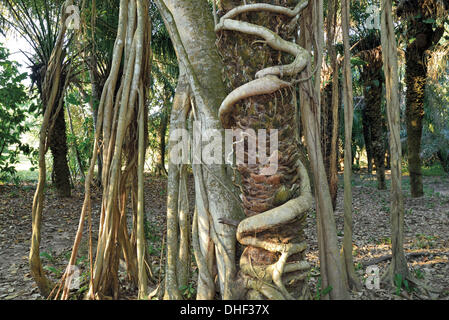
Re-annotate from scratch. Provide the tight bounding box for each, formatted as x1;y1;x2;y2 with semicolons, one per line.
397;0;449;198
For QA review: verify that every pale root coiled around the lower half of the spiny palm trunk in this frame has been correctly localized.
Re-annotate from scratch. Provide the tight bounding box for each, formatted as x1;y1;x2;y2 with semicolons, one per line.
237;161;313;300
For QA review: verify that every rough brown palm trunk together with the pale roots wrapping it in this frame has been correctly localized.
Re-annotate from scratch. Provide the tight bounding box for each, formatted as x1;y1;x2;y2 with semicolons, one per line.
212;1;311;299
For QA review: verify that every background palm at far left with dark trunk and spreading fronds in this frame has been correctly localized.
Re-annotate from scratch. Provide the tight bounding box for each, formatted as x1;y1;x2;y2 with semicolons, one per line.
3;0;71;197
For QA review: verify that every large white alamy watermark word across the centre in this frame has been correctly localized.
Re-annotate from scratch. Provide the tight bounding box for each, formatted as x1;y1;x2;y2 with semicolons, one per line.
169;121;279;176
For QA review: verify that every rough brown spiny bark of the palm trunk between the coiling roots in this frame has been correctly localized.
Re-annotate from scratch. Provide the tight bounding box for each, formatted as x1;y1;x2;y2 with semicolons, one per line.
218;0;310;299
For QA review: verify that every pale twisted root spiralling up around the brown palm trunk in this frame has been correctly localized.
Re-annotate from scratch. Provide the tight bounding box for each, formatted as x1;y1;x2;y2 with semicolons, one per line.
215;0;313;300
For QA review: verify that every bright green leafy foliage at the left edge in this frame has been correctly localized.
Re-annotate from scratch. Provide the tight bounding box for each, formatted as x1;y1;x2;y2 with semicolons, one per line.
0;45;37;180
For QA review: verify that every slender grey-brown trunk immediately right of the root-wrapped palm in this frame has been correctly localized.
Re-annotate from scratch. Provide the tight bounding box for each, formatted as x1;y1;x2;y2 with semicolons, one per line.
300;3;349;299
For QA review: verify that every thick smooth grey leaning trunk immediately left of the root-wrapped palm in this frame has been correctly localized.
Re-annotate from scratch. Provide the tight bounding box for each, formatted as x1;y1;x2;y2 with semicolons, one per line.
156;0;242;299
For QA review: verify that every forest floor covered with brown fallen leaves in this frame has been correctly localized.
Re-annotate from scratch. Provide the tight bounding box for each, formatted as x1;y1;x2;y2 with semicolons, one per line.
0;174;449;300
